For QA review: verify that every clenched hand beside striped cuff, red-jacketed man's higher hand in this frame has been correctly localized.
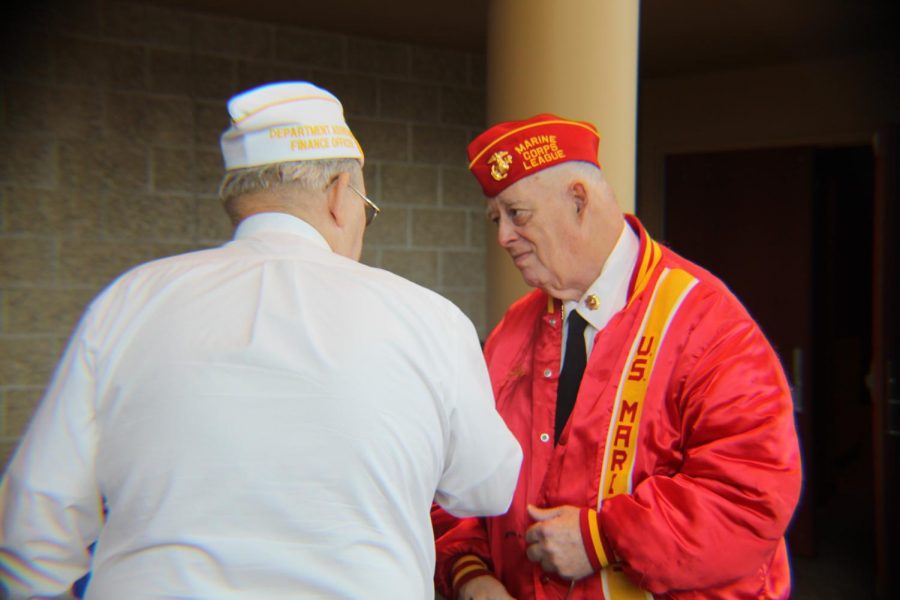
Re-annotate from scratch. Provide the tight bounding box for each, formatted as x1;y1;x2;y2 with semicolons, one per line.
525;504;594;579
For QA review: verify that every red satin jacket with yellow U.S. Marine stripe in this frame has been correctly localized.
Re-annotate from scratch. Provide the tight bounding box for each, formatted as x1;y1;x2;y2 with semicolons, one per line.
434;216;801;600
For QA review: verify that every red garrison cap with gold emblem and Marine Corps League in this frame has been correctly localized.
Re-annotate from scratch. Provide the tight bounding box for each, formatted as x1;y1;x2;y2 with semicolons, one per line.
469;114;600;198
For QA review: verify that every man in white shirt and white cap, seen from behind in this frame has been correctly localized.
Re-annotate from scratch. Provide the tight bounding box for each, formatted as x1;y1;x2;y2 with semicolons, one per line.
0;82;521;599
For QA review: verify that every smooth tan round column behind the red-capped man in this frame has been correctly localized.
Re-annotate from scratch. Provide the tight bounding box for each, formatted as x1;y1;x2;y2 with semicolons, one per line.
487;0;640;328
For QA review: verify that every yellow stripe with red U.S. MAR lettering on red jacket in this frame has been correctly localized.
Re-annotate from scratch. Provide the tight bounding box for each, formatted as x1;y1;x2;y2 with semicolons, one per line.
597;269;697;600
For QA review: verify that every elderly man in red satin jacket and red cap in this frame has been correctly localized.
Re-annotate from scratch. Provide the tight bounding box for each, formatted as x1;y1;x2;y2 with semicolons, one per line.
435;114;801;600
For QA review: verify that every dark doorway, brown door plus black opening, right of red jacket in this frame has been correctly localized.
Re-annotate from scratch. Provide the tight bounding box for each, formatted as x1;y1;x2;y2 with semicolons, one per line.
664;146;875;598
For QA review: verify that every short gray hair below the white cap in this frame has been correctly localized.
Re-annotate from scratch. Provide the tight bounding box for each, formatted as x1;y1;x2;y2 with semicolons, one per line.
219;158;361;203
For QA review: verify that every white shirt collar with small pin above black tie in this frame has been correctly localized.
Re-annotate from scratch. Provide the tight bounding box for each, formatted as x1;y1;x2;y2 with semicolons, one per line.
563;223;640;331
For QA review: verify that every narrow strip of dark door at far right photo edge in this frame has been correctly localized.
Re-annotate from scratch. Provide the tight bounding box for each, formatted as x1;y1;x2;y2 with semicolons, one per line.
870;126;900;599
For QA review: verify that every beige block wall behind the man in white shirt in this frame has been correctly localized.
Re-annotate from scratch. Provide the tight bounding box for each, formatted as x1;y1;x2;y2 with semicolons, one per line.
0;0;486;464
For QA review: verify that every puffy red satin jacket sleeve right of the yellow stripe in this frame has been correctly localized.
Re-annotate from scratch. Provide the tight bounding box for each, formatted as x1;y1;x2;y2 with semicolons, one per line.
598;300;801;593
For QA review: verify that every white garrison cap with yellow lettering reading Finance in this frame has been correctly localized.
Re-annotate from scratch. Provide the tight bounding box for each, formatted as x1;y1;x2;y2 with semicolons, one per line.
221;81;363;171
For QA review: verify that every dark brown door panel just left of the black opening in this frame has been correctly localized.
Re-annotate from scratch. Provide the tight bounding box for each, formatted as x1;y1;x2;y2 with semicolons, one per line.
664;148;816;555
